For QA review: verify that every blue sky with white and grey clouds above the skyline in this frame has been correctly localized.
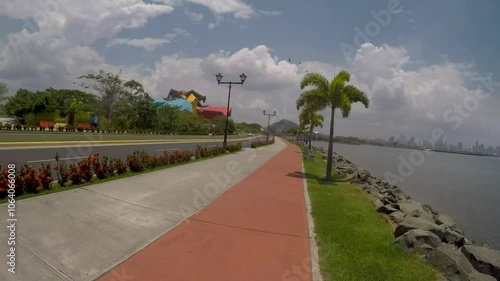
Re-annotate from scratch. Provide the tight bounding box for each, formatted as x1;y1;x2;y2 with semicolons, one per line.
0;0;500;146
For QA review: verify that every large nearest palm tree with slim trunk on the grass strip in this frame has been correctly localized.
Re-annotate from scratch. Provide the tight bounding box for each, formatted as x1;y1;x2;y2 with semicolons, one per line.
296;71;370;181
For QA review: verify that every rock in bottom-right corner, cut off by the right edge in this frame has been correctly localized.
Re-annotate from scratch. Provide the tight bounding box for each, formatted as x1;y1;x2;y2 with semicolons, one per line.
462;245;500;280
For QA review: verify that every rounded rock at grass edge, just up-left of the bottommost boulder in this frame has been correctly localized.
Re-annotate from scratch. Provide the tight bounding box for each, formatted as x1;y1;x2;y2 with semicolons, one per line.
396;229;441;254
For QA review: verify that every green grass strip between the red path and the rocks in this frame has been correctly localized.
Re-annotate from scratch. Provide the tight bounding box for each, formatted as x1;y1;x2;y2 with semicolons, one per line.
304;151;439;281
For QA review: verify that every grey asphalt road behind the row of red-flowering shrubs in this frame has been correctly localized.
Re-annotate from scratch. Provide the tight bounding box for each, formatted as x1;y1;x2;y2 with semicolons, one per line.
0;136;266;168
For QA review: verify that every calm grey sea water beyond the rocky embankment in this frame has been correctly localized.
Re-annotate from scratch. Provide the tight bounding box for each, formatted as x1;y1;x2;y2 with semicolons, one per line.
313;142;500;249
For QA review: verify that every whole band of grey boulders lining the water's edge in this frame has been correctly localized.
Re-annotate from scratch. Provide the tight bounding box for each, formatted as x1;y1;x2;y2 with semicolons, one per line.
316;148;500;281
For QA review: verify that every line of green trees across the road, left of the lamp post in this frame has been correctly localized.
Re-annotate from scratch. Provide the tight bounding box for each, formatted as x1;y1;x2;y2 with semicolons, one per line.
0;71;260;134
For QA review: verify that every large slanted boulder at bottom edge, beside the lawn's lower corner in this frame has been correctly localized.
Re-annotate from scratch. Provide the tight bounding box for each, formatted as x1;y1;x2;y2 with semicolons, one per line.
427;244;495;281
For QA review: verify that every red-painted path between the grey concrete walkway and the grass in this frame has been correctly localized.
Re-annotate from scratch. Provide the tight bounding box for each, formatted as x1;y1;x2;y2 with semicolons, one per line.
98;139;311;281
